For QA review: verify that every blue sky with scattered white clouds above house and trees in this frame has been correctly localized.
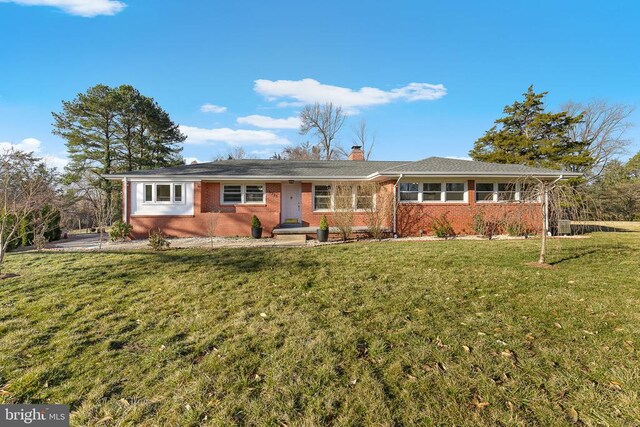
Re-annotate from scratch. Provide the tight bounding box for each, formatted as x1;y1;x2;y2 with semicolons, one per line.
0;0;640;165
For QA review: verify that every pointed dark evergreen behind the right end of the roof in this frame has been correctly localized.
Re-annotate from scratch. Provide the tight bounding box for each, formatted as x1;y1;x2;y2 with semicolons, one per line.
469;86;593;171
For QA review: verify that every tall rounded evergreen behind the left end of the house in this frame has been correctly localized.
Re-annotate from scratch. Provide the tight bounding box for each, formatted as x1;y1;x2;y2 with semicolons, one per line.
53;85;186;185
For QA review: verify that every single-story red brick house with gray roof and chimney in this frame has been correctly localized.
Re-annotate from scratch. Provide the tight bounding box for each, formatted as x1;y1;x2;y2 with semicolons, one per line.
107;146;576;238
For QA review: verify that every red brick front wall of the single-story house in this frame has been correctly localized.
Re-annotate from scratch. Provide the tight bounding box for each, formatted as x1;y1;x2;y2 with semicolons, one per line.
127;180;542;238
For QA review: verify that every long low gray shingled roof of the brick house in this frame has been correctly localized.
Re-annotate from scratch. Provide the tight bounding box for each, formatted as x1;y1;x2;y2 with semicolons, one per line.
108;157;575;179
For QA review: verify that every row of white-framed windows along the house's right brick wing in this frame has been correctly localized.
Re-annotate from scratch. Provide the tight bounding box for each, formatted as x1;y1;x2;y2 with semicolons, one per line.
399;182;539;203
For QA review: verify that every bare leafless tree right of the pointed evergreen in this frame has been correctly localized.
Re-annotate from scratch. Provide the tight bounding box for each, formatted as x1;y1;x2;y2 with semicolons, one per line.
562;100;634;178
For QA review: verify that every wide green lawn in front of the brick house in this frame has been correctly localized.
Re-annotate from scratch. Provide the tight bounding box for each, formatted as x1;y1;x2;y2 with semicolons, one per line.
0;233;640;426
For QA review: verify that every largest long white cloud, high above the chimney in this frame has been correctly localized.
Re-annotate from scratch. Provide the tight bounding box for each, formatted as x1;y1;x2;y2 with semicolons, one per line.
254;79;447;112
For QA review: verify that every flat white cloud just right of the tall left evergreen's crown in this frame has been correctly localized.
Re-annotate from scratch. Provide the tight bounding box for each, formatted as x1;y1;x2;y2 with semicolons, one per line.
180;125;289;147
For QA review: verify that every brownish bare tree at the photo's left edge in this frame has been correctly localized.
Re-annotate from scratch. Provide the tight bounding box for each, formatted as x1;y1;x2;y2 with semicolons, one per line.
0;150;57;267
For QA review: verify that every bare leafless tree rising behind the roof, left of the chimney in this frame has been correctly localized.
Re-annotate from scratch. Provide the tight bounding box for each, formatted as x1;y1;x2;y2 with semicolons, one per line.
300;102;346;160
